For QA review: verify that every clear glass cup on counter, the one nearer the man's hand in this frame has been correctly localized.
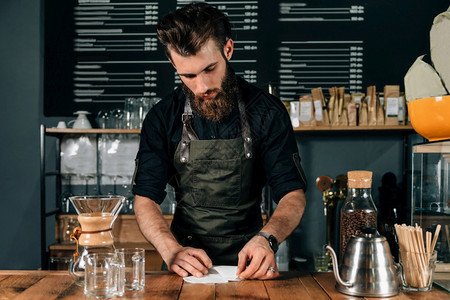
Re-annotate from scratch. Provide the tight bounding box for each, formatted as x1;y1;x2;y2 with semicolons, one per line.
116;248;145;291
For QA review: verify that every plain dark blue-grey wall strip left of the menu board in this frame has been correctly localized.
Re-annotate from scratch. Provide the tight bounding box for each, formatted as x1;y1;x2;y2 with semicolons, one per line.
0;0;42;269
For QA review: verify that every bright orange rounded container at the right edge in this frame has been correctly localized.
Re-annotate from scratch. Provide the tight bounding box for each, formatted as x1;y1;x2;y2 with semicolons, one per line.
408;95;450;142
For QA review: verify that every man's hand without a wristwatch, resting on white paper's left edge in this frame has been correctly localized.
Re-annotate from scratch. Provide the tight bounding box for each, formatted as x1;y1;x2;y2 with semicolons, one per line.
166;247;212;277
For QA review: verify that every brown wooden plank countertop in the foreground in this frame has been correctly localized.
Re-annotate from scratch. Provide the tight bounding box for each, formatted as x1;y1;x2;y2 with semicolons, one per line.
0;271;450;300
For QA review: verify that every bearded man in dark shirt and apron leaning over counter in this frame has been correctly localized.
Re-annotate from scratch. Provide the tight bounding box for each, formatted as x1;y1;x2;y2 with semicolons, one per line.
133;3;306;279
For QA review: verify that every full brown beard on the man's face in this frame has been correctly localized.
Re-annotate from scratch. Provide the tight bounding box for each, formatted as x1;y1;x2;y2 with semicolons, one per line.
182;64;237;122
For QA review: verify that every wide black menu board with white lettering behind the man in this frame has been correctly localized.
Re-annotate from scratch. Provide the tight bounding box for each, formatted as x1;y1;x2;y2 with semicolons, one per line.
44;0;449;116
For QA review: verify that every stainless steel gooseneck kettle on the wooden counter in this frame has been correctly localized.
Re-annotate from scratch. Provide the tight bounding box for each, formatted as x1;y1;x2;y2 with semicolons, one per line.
326;229;401;297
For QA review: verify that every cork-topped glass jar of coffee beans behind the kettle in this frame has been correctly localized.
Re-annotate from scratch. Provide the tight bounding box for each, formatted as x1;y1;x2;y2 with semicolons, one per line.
340;171;377;260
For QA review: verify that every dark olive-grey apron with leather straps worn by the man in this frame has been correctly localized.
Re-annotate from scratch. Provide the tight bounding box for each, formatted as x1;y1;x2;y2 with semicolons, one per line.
171;97;262;265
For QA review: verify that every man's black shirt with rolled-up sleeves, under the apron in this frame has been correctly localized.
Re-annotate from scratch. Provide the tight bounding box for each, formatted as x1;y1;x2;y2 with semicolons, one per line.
133;77;306;204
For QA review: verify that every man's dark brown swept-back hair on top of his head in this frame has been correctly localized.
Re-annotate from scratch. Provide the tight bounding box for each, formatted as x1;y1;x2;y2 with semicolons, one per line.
156;2;231;59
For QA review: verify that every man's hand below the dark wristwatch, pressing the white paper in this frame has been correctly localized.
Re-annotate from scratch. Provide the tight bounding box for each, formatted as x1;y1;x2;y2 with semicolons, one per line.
236;236;280;279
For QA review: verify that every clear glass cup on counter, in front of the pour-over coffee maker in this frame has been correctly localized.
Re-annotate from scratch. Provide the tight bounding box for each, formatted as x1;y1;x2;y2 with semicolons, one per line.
84;253;124;299
